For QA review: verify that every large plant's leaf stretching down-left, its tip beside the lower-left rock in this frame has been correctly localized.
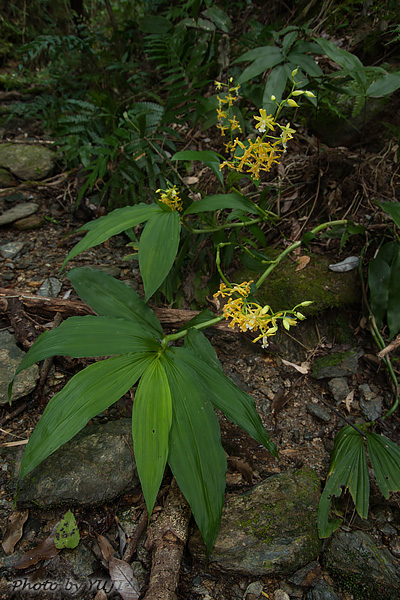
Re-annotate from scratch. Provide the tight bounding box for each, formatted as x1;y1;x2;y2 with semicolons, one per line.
19;352;154;478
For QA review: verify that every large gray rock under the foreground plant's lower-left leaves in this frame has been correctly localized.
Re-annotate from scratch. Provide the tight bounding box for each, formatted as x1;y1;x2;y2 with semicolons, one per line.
18;419;139;506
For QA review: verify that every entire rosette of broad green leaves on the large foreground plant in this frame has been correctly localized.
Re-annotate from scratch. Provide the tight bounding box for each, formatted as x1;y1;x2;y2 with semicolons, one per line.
9;268;276;551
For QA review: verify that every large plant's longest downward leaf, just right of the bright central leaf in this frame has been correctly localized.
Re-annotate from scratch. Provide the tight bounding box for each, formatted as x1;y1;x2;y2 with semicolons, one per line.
161;348;226;552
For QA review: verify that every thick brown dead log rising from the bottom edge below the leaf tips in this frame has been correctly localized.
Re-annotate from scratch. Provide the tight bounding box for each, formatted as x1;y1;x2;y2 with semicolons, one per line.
144;479;191;600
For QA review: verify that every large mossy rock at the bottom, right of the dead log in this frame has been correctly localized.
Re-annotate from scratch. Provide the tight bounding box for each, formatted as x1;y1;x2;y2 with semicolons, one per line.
189;469;321;575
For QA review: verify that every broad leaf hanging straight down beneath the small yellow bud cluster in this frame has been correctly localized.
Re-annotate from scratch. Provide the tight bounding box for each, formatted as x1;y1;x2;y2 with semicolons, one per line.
139;210;181;300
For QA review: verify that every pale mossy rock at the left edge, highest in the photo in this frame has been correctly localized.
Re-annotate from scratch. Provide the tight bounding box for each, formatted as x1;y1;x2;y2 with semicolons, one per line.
0;143;55;181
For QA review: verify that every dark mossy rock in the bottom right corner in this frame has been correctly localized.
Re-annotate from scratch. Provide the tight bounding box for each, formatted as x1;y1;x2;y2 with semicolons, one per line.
325;531;400;600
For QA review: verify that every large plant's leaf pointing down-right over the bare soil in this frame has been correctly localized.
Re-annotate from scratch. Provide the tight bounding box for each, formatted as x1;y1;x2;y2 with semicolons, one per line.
168;348;277;456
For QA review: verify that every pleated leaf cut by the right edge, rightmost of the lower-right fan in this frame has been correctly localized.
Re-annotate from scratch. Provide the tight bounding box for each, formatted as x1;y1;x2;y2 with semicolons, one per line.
367;432;400;498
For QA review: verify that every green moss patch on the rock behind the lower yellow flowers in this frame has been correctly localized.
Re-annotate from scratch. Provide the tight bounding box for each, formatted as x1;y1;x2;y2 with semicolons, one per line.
232;250;361;315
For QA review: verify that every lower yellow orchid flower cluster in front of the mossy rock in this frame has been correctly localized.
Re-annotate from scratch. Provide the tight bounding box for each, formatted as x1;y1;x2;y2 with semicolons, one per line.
214;281;311;348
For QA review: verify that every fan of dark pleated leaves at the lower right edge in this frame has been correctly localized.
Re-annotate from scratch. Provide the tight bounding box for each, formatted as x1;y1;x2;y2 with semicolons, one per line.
318;425;400;538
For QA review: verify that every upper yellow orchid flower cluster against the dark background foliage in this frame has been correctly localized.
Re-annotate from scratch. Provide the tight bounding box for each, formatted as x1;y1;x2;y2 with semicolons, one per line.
214;69;314;180
